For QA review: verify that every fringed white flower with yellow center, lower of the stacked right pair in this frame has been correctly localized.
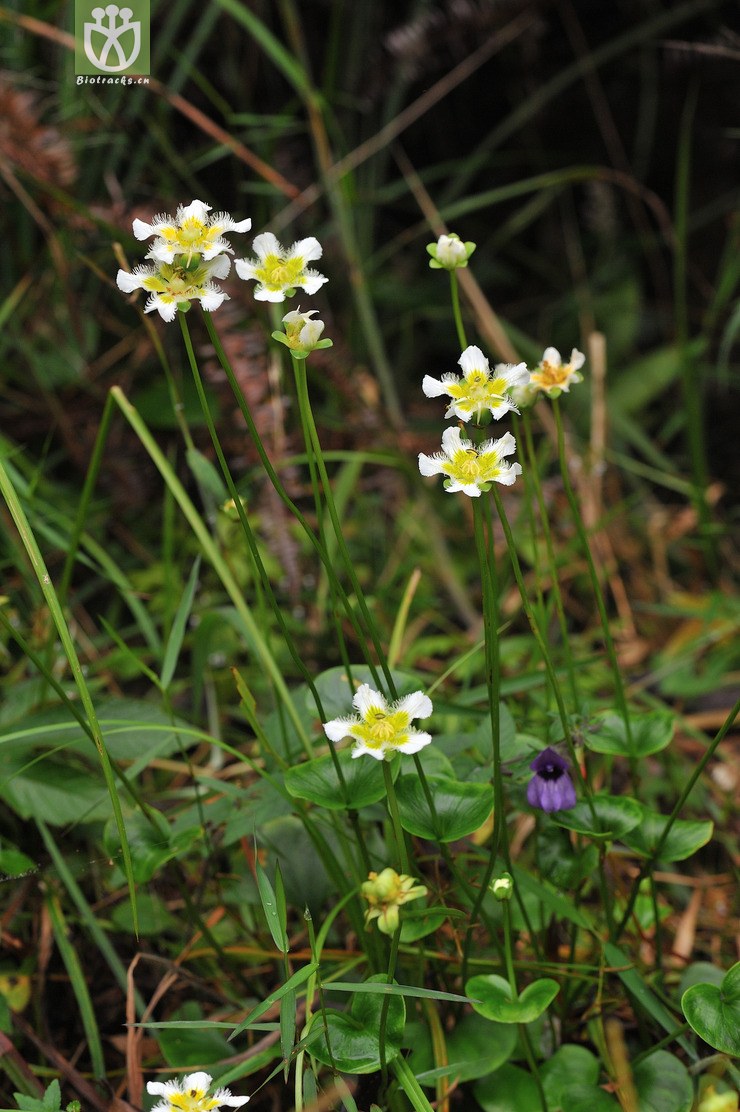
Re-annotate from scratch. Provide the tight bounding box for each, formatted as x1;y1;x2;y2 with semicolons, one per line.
418;428;522;498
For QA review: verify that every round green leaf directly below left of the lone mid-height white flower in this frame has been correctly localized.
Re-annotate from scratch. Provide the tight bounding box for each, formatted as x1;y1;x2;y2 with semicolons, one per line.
285;748;401;811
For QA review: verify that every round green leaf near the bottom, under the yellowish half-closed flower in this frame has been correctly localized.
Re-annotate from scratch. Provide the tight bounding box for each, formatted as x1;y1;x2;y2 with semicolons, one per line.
310;973;406;1073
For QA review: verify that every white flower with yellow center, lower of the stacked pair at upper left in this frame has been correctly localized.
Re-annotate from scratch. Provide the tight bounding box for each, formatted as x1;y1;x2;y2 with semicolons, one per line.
116;255;231;321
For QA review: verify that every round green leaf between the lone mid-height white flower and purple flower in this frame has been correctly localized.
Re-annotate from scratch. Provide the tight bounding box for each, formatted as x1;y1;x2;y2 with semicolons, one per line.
396;776;493;842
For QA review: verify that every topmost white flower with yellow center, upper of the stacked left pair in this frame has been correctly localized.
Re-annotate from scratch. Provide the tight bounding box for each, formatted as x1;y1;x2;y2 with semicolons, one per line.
134;201;251;262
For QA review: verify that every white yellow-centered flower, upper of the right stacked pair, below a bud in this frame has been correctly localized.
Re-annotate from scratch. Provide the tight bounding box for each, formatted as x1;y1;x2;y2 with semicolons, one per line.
422;346;530;424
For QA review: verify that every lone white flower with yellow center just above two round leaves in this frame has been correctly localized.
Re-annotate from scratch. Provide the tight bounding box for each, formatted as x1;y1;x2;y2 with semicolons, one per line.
324;684;432;761
